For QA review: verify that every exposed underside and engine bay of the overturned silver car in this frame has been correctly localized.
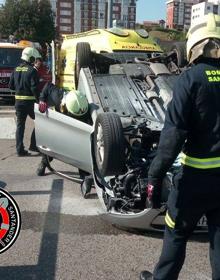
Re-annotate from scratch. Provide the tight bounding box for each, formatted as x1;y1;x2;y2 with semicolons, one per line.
76;48;206;230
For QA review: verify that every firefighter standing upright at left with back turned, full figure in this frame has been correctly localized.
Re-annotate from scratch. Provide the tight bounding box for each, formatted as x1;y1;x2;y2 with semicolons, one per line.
9;47;41;156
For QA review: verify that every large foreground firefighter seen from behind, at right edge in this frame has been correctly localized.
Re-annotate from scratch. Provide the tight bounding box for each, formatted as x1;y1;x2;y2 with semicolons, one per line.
140;14;220;280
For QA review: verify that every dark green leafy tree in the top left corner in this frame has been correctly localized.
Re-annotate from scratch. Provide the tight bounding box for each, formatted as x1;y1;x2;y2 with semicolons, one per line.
0;0;55;43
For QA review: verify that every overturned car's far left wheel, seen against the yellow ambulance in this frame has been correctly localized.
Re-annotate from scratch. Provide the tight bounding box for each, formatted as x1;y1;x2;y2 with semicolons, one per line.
75;42;92;88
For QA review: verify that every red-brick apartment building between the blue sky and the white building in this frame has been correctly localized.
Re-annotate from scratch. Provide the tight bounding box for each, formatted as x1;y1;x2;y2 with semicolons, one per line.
166;0;200;30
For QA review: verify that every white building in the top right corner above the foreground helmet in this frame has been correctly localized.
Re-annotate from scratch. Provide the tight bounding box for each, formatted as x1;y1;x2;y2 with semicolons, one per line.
191;0;220;25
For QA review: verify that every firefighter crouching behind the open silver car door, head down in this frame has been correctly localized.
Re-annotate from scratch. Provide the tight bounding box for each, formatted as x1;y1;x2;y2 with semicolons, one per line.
37;83;89;176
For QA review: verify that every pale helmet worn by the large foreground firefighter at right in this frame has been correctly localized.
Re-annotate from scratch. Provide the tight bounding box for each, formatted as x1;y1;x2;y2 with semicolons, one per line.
186;13;220;63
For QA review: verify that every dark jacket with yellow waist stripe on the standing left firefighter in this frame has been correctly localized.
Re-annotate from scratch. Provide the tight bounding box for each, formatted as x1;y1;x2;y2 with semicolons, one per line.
9;61;39;101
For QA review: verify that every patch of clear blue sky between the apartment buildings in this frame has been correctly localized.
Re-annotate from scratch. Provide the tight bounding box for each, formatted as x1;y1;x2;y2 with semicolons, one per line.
136;0;166;23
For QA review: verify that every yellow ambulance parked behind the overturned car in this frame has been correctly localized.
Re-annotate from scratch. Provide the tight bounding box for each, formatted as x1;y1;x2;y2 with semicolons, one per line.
54;28;163;90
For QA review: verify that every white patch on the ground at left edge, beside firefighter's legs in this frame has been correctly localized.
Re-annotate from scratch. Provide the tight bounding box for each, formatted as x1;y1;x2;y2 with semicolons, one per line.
0;118;16;139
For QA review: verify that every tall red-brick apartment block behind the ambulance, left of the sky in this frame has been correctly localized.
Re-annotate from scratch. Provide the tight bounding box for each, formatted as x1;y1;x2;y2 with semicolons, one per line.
56;0;136;34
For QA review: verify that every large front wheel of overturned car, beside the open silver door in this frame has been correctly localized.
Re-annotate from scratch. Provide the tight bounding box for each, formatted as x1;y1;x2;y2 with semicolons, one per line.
94;113;125;176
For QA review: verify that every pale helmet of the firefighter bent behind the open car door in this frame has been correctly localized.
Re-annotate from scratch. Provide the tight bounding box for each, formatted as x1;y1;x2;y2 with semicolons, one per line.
65;90;88;117
